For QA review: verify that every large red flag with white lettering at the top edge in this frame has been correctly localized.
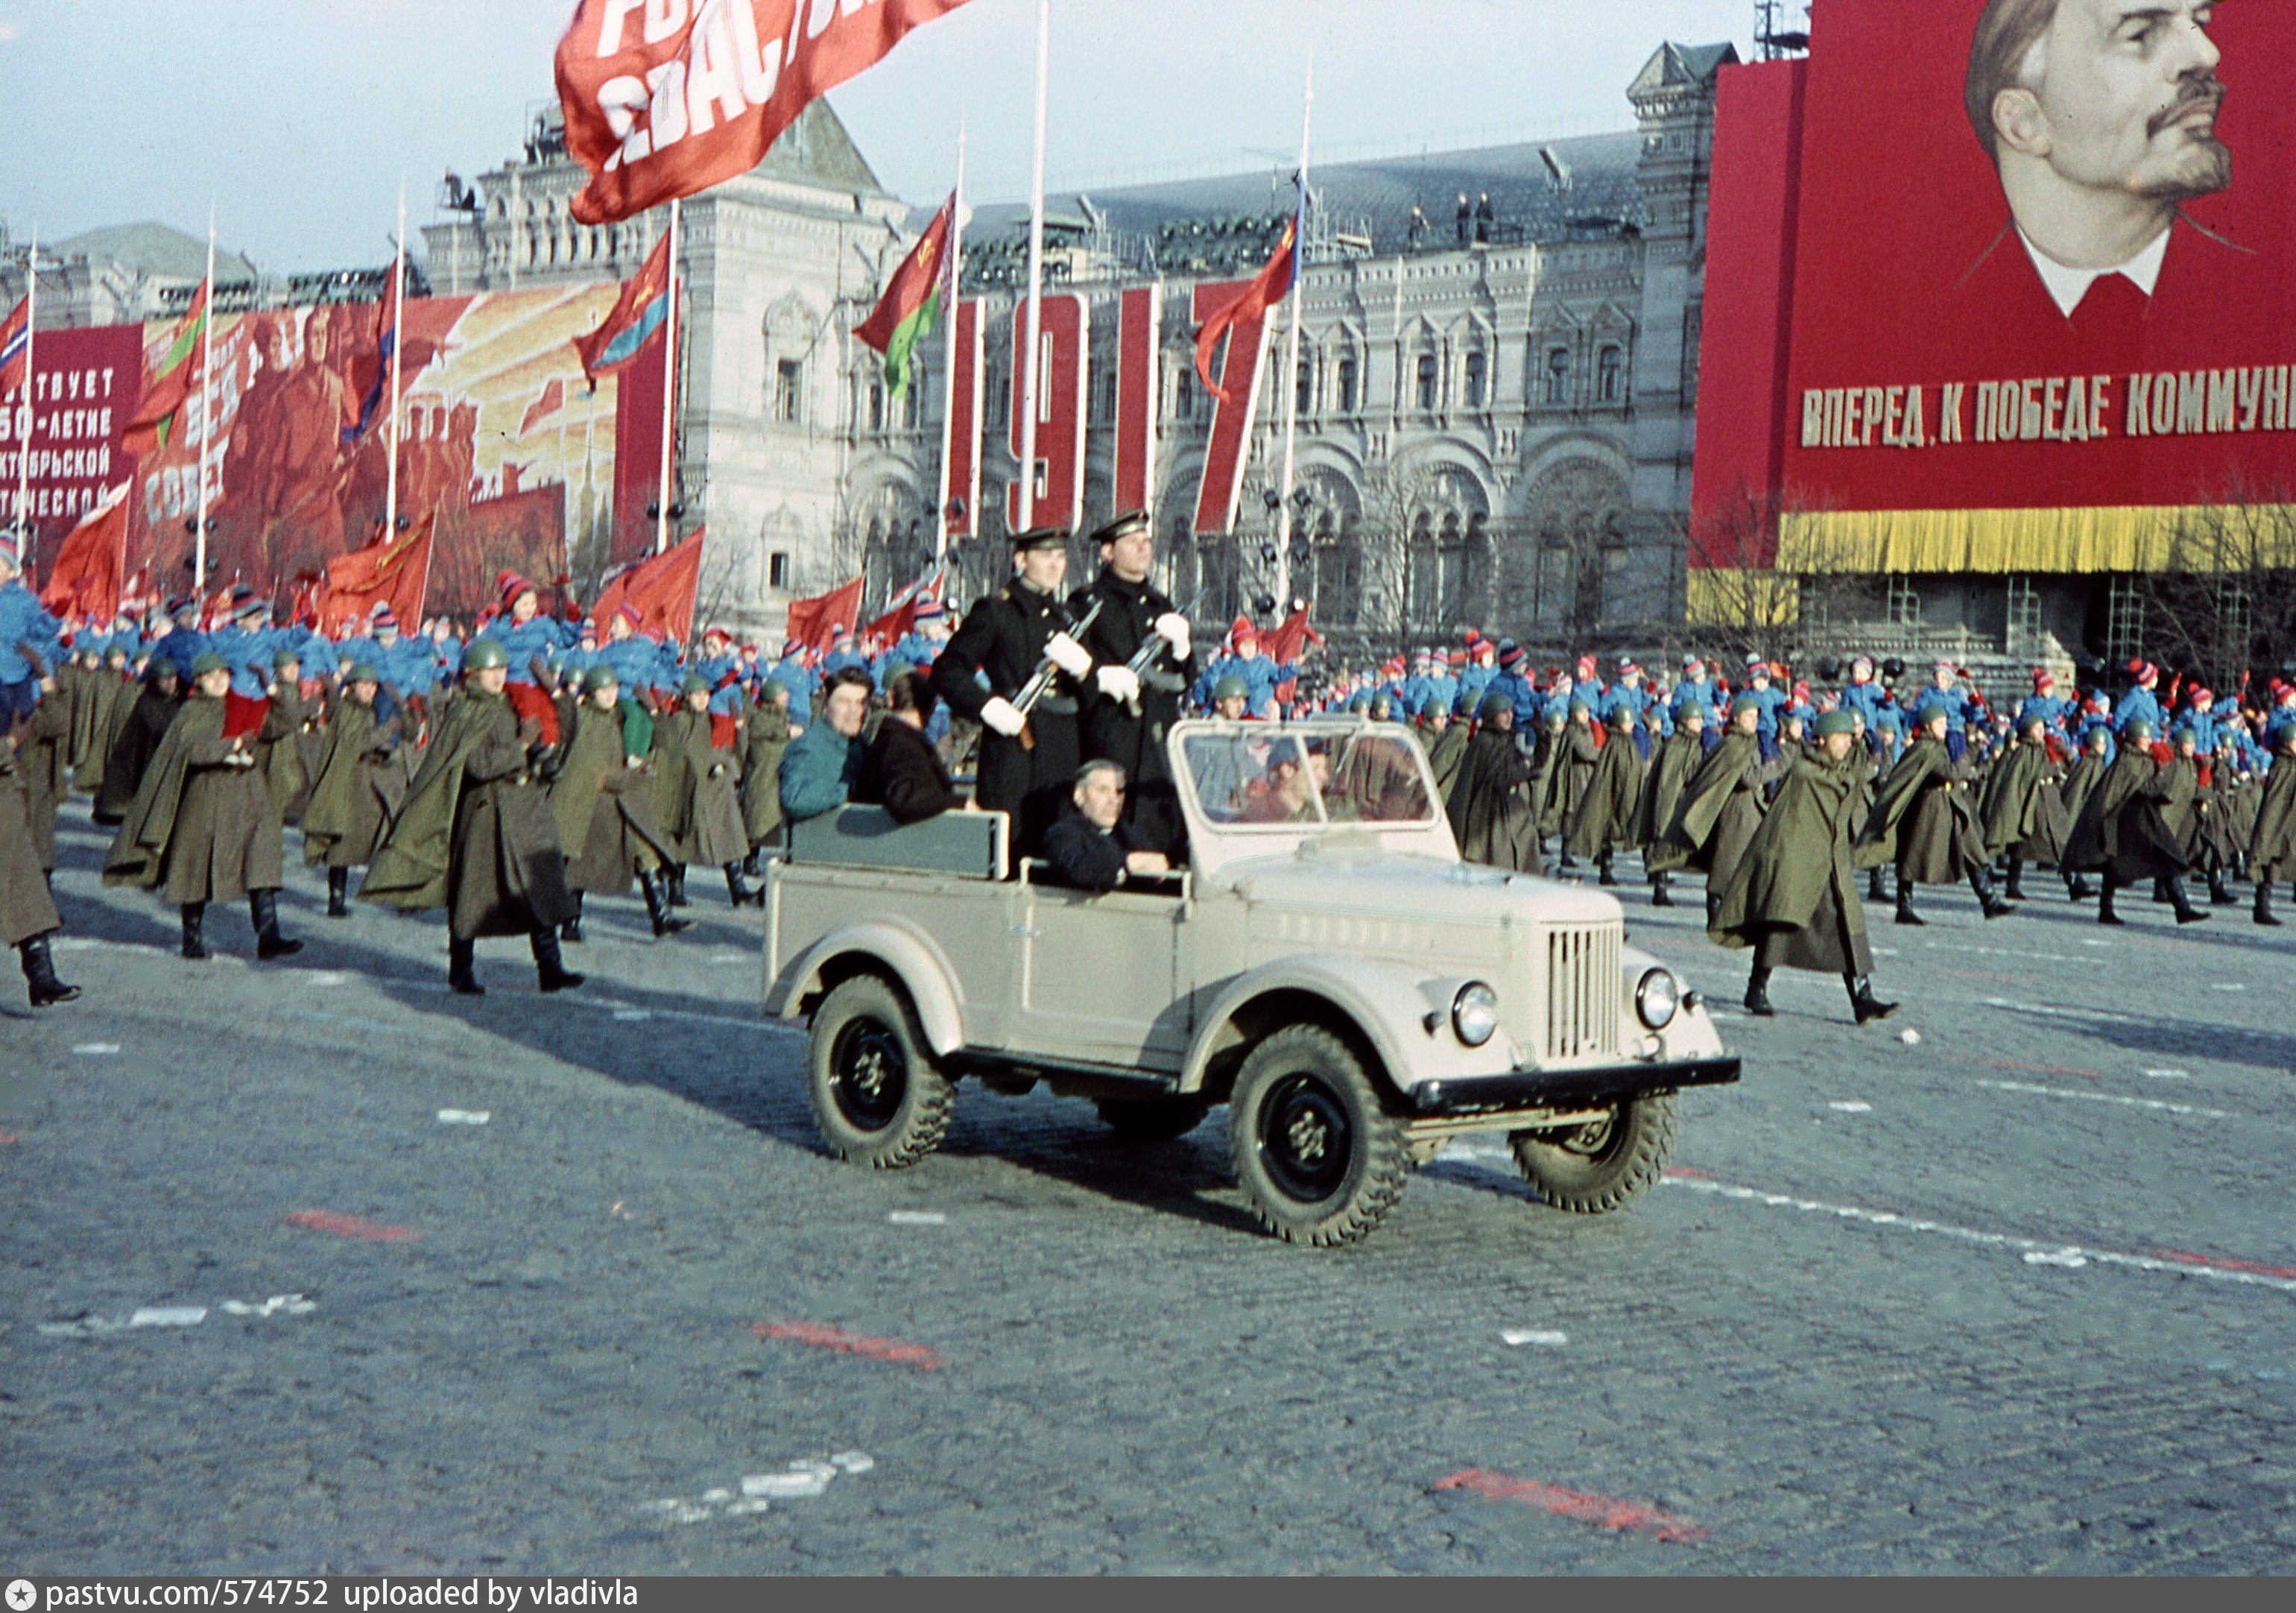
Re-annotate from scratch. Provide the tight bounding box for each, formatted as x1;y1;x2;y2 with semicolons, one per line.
558;0;987;225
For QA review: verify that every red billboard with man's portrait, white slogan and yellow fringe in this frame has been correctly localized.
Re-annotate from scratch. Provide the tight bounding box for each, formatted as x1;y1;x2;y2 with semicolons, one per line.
1699;0;2296;569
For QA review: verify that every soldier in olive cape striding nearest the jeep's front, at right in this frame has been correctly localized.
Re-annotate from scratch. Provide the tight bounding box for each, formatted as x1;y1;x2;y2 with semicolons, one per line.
1706;710;1897;1025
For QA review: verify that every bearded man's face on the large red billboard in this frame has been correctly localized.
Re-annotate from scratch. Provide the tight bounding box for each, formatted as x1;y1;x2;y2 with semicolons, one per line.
1967;0;2232;269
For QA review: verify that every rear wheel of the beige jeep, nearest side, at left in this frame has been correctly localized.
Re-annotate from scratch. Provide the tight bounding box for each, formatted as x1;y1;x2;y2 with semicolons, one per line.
806;974;955;1169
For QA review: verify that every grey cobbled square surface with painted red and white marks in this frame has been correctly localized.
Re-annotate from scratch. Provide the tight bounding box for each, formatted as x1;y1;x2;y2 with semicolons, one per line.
0;804;2296;1574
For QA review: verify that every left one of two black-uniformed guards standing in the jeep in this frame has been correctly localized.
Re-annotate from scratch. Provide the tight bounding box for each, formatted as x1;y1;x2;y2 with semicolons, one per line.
932;528;1111;857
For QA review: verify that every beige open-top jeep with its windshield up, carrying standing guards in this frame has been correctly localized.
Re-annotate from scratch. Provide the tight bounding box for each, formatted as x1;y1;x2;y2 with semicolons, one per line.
765;719;1738;1243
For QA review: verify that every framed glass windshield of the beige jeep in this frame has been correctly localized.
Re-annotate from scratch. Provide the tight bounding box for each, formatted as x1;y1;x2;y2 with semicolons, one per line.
1180;724;1438;834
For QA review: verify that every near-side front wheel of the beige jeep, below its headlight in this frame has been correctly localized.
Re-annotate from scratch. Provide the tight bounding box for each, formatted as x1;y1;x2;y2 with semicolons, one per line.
1228;1025;1410;1248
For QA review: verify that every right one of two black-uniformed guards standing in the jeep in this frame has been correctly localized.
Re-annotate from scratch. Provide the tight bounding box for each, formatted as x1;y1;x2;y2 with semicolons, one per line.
1068;515;1196;857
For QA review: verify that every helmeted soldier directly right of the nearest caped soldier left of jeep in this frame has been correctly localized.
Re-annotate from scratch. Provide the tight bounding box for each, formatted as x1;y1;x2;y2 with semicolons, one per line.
551;662;693;944
